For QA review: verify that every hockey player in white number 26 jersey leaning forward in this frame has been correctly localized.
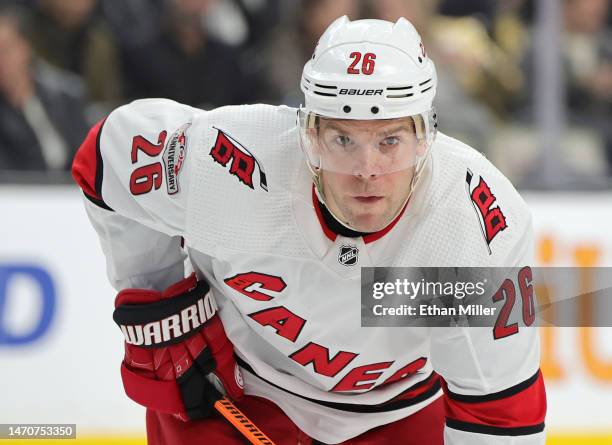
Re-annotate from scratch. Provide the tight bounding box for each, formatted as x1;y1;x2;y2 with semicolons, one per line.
73;17;546;445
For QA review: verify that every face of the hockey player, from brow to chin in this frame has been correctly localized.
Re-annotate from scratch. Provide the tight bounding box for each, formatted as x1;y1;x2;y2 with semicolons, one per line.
318;119;423;232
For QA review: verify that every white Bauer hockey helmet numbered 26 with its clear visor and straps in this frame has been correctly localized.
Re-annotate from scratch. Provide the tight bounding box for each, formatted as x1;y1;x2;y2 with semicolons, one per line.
298;16;437;224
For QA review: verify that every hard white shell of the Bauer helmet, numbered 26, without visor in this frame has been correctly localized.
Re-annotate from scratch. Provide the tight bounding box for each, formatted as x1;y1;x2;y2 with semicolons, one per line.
300;16;437;120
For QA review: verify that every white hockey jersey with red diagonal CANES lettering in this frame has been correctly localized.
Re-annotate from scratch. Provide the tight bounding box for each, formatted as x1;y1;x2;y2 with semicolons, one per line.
73;99;546;445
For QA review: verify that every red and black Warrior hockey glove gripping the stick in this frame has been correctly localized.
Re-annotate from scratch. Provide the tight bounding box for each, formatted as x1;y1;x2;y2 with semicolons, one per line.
113;274;243;420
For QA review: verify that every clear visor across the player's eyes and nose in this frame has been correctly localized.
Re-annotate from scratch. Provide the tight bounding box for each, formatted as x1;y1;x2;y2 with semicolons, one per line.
299;109;435;177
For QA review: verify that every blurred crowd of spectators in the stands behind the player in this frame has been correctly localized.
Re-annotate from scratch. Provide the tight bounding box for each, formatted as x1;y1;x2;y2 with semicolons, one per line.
0;0;612;187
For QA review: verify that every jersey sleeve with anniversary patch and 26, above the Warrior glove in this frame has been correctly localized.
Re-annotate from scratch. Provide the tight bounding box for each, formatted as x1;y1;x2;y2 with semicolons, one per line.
72;99;204;289
